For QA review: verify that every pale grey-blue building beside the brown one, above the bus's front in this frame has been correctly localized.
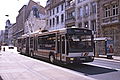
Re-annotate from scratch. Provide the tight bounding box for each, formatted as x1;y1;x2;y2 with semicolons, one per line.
75;0;98;37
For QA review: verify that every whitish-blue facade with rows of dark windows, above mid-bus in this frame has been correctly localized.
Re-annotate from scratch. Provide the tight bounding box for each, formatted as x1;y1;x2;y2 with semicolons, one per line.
46;0;65;30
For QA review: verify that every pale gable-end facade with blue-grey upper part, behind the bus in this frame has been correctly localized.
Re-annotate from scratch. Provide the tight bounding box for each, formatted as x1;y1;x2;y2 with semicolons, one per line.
24;5;46;34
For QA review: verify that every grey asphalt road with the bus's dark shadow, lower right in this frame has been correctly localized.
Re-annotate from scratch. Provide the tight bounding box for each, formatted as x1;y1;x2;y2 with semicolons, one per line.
54;58;120;80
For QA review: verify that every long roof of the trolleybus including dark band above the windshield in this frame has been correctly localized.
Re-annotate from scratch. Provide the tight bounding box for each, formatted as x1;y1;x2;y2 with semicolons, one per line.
18;27;92;39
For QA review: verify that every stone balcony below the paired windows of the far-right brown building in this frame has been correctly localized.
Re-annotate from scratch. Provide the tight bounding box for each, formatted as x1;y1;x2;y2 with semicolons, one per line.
102;15;120;25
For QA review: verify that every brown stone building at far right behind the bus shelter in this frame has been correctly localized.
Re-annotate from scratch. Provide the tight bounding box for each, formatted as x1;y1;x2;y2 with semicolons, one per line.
98;0;120;55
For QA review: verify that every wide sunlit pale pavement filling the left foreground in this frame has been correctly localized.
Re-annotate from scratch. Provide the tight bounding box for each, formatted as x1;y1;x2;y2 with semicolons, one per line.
0;52;95;80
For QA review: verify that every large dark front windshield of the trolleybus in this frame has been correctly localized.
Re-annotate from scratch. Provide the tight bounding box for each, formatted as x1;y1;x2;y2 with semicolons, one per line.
68;35;93;52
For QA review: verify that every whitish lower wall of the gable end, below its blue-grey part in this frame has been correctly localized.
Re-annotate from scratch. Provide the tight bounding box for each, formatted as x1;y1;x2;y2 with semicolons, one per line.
24;11;46;34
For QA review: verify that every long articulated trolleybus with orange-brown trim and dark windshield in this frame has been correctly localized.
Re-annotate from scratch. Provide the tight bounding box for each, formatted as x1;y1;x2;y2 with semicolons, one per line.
18;28;94;63
